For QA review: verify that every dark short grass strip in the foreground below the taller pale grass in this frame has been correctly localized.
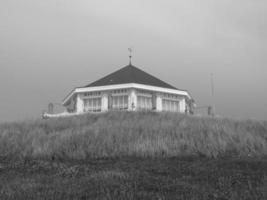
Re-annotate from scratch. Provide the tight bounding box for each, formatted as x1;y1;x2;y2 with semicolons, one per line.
0;157;267;200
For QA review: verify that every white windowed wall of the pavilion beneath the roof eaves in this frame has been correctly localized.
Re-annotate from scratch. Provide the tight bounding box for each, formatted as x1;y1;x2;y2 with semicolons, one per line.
72;88;186;113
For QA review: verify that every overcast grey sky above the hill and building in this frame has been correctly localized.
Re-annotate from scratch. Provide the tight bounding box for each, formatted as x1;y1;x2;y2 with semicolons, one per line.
0;0;267;122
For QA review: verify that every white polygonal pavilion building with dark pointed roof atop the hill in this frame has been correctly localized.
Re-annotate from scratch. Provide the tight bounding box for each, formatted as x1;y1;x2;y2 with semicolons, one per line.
59;62;192;114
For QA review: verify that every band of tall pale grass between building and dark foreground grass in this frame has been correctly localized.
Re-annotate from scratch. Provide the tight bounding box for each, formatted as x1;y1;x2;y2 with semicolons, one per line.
0;112;267;159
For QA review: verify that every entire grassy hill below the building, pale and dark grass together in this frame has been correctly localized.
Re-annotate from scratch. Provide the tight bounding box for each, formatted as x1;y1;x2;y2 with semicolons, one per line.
0;112;267;200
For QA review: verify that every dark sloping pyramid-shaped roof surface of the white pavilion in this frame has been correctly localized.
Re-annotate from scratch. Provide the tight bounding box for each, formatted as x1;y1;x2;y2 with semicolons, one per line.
85;64;177;89
